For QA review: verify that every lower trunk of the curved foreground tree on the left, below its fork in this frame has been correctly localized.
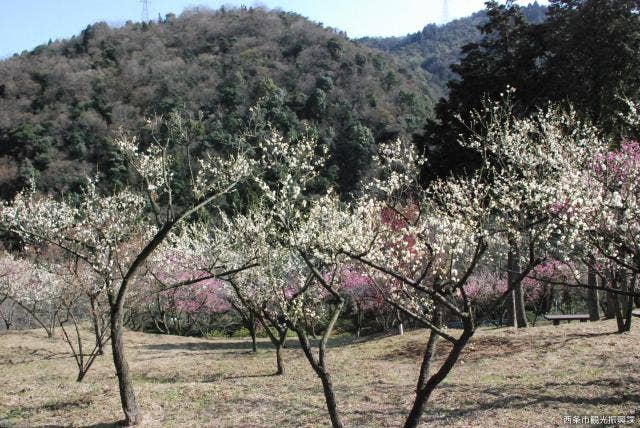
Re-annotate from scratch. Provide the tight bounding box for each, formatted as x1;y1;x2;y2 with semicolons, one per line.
111;305;141;425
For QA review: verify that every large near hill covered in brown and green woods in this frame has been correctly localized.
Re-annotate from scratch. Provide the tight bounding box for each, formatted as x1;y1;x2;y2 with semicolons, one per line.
0;8;436;197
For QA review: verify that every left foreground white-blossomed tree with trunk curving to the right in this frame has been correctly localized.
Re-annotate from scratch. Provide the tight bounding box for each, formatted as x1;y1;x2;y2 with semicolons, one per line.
1;112;259;424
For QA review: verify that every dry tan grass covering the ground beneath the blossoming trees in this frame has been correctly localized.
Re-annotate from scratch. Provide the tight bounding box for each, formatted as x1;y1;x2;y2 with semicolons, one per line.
0;321;640;427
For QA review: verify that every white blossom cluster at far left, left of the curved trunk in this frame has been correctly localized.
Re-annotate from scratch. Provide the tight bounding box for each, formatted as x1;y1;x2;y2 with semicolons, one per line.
0;180;153;290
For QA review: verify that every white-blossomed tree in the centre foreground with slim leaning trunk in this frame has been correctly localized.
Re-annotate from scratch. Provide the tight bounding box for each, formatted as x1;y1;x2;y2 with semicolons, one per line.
225;128;355;427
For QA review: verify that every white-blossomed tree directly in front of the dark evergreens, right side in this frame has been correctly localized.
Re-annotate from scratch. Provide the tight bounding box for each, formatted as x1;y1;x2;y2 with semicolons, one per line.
465;93;606;327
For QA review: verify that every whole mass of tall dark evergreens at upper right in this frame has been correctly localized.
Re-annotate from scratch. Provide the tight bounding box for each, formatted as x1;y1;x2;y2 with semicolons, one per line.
416;0;640;180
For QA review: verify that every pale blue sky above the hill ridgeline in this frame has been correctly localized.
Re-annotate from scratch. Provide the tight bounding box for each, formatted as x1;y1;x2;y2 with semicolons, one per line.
0;0;546;58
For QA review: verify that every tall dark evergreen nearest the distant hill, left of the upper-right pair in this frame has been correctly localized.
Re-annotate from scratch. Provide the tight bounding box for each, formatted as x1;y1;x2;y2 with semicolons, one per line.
415;0;543;180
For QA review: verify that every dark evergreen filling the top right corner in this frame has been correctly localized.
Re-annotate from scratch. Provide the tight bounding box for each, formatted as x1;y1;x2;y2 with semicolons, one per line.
543;0;640;132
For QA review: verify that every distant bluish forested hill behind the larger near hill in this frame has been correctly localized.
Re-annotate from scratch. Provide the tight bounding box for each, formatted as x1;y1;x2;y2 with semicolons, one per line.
360;2;547;98
